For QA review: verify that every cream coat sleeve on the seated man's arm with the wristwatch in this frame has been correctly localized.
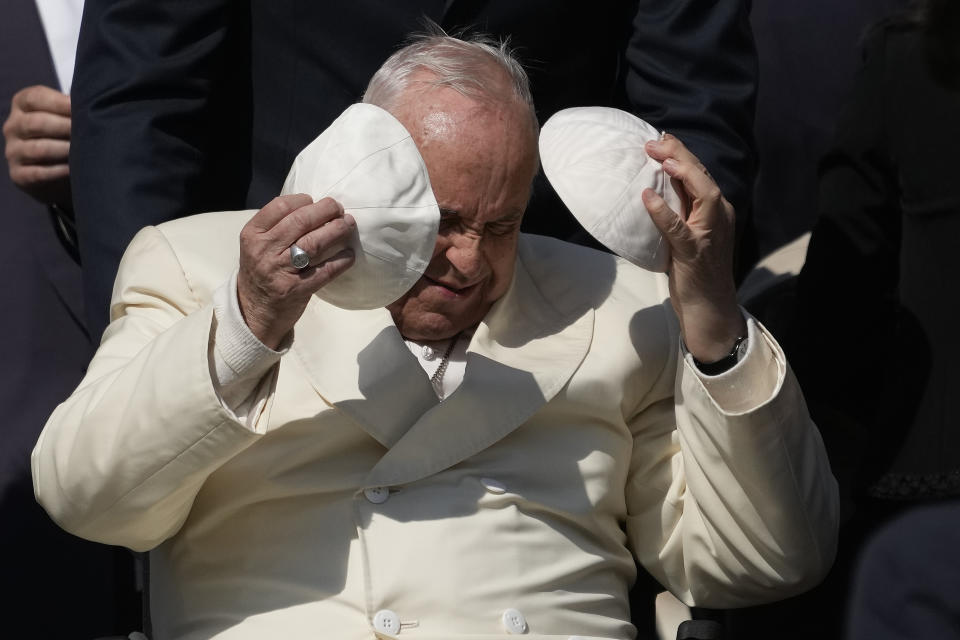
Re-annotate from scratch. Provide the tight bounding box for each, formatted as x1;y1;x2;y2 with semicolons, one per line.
627;308;838;608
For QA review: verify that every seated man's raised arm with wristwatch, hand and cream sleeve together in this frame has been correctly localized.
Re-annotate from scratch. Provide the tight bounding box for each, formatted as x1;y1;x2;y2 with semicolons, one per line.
627;137;839;608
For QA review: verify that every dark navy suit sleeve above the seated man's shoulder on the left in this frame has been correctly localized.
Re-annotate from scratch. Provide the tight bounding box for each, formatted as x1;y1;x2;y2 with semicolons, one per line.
70;0;250;336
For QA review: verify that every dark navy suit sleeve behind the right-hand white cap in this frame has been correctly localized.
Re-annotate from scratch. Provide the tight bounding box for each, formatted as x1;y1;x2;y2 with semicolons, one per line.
626;0;758;222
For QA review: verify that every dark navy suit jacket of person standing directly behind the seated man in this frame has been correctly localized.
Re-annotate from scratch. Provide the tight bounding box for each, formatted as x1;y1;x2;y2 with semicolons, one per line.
71;0;756;340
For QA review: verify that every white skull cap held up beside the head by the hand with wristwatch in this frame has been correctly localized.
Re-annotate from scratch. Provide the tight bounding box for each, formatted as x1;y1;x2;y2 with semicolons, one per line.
540;107;681;271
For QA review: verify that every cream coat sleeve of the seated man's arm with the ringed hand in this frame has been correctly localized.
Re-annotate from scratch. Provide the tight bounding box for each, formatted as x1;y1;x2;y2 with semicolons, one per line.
32;227;268;551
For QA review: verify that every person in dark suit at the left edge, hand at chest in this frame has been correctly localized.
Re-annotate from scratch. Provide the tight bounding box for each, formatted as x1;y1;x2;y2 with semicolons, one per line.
0;0;139;640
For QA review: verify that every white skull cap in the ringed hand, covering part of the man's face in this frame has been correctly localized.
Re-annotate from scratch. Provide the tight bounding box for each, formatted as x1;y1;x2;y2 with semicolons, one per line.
281;104;440;309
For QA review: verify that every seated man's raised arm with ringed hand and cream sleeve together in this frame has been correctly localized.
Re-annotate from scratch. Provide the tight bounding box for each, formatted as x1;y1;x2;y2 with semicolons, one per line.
32;194;353;550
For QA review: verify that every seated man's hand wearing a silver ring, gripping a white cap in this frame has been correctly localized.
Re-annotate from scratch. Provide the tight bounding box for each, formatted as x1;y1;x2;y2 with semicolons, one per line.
237;193;356;349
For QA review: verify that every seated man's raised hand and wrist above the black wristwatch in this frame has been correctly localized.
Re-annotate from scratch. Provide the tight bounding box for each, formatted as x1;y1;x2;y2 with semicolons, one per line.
643;134;747;362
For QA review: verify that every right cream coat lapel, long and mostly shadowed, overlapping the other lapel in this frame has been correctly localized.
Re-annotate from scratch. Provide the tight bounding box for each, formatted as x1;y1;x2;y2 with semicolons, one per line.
366;249;593;486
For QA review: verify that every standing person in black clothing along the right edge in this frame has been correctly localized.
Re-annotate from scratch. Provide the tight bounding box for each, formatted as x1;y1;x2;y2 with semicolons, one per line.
727;0;960;640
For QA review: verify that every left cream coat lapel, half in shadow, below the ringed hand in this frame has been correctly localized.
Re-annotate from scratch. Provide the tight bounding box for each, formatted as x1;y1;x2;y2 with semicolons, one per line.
291;297;438;448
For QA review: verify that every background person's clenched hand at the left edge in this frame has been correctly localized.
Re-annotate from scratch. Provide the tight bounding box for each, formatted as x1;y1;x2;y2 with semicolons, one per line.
3;85;72;211
